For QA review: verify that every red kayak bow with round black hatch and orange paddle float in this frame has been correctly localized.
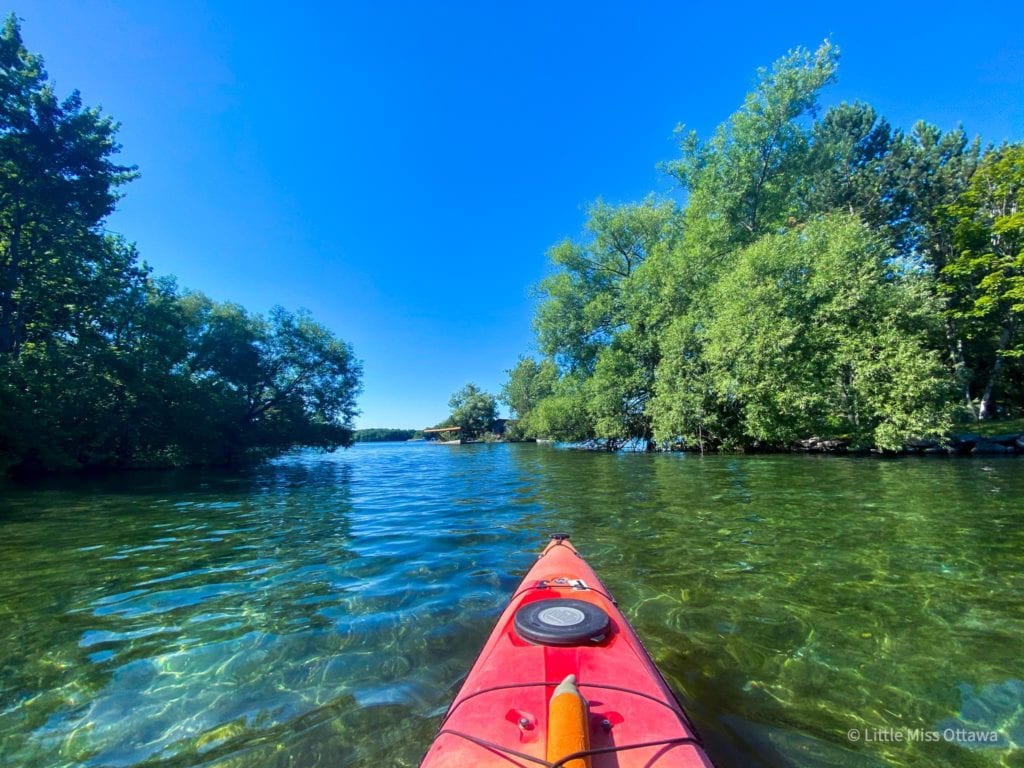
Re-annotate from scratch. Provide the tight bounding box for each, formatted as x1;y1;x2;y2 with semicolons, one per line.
421;535;713;768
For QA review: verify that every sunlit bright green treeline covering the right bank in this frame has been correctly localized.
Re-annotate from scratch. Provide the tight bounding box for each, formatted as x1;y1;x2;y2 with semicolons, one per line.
502;42;1024;450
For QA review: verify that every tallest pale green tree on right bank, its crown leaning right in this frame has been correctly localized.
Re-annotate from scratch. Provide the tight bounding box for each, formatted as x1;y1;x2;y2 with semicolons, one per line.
645;41;839;449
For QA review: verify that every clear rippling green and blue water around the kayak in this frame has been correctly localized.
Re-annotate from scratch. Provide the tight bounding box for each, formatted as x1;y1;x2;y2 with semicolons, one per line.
0;443;1024;768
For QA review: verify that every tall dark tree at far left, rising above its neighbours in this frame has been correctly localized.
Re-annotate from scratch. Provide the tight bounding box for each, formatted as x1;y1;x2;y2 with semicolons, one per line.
0;14;135;357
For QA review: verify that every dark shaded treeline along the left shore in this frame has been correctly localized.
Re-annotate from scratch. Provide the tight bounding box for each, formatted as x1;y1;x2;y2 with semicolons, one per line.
0;15;360;471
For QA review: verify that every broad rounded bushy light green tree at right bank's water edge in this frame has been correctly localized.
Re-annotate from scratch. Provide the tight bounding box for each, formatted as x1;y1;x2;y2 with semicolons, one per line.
655;215;947;449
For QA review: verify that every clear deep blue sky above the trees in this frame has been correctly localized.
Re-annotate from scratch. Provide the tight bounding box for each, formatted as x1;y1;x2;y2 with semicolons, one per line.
8;0;1024;427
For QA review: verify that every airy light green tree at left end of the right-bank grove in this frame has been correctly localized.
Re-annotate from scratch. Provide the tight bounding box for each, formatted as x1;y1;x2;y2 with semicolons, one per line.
528;198;678;440
